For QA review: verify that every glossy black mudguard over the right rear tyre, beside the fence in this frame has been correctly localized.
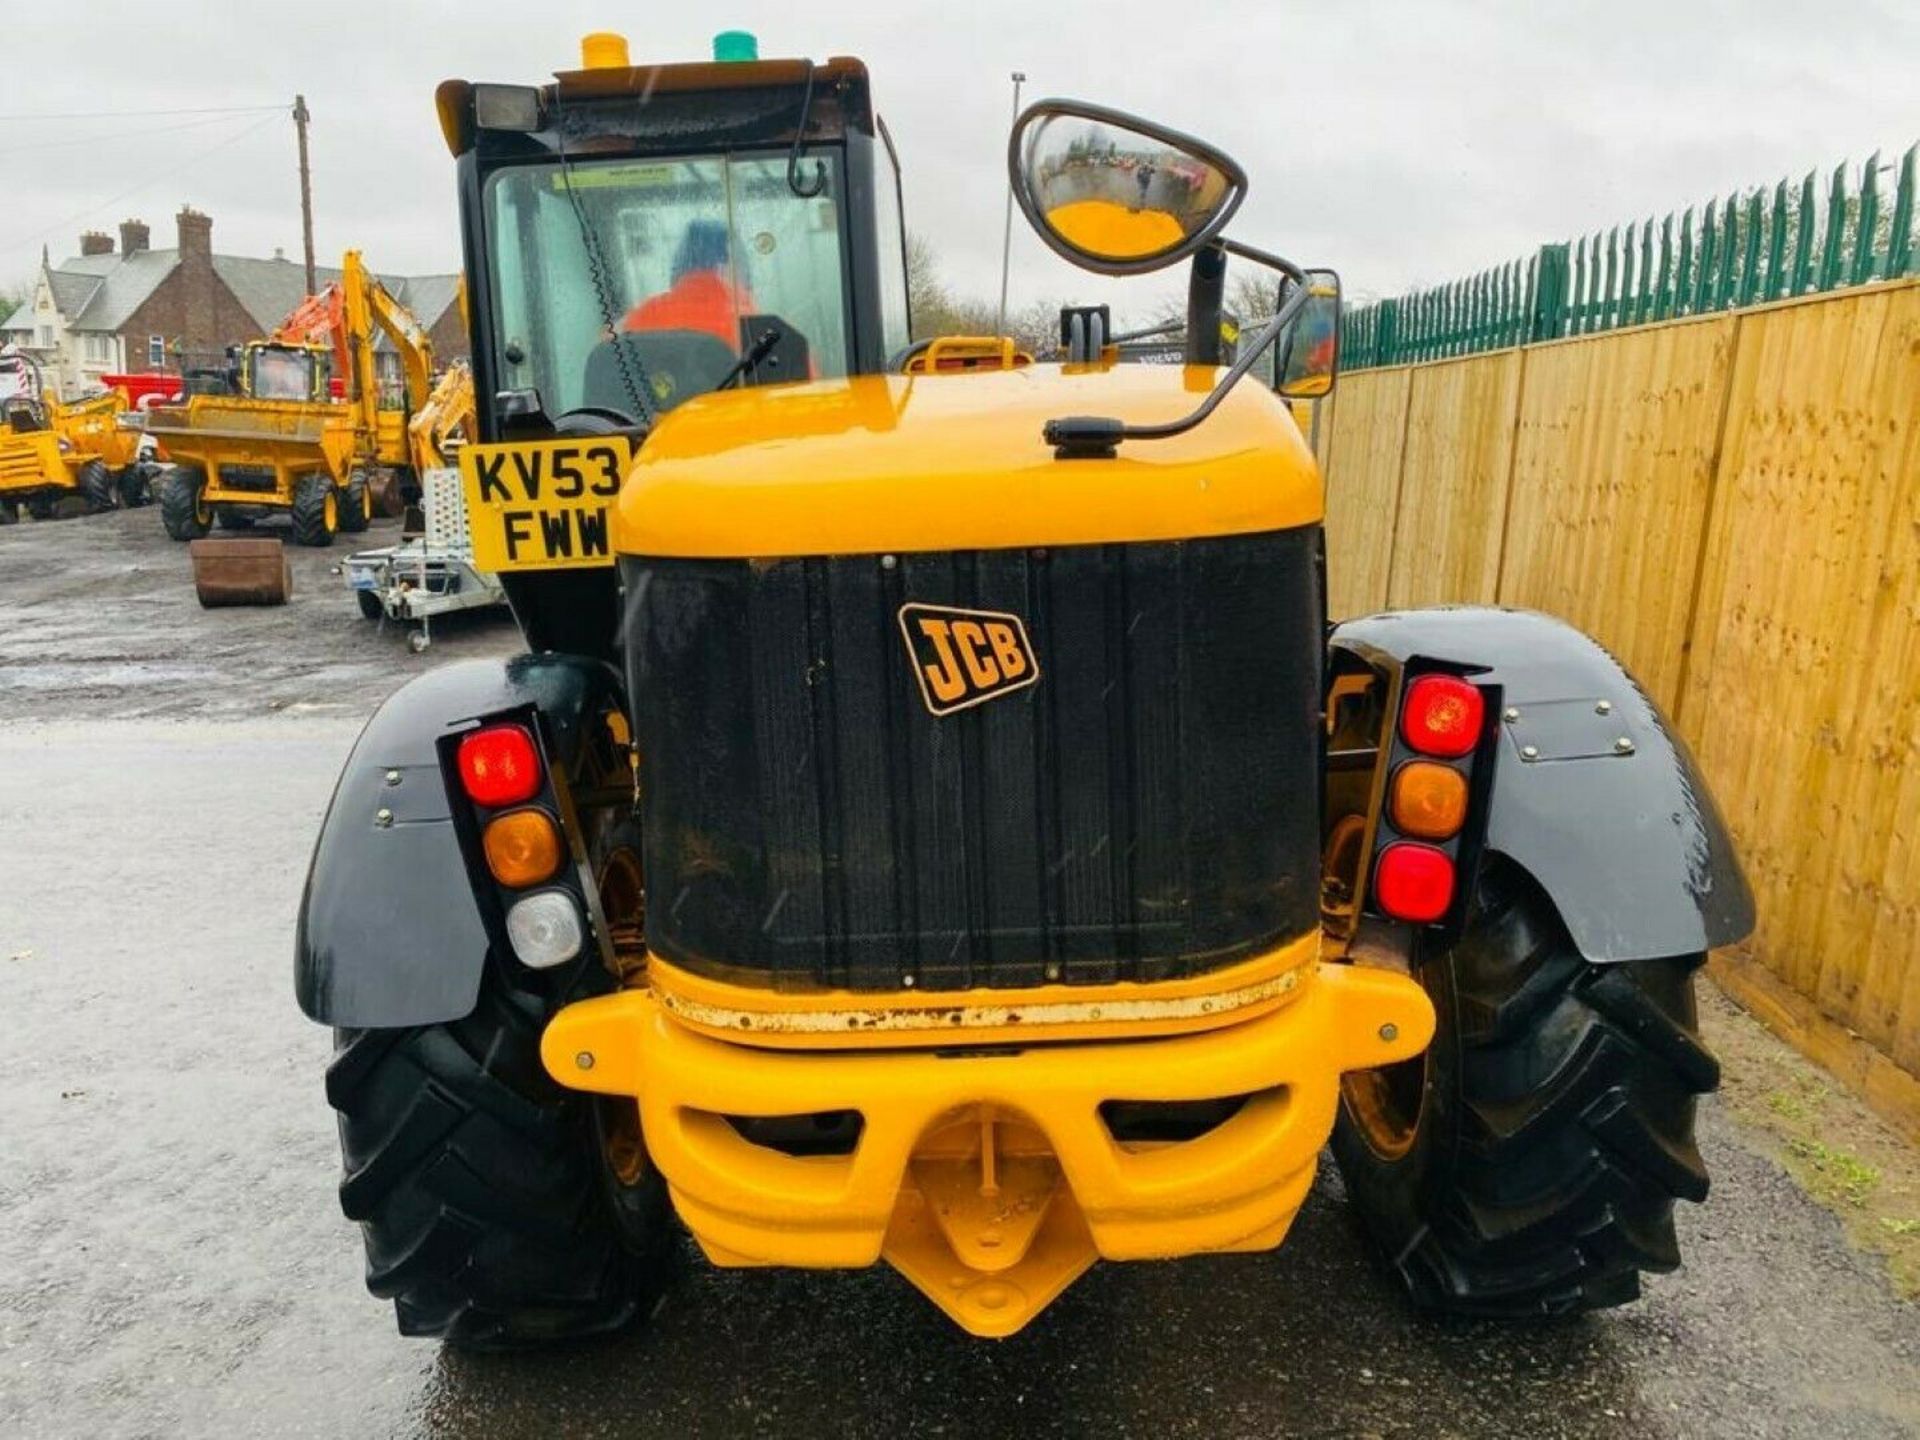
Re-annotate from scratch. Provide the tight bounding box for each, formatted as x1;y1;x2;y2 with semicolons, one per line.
1331;607;1753;960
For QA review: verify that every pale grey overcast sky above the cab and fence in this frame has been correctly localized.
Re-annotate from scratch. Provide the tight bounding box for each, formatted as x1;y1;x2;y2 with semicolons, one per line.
0;0;1920;324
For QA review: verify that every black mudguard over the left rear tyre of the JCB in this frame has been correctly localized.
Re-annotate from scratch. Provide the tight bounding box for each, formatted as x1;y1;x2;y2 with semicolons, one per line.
294;655;614;1029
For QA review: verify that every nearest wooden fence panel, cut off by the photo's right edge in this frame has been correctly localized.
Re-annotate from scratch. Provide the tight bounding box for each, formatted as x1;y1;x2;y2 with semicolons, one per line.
1680;286;1920;1073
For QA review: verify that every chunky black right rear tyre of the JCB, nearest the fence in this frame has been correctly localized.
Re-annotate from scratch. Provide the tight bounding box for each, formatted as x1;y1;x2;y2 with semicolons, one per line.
1332;860;1720;1319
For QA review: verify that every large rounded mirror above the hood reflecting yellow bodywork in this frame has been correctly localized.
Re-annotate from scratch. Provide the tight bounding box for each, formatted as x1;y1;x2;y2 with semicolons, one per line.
1006;100;1246;275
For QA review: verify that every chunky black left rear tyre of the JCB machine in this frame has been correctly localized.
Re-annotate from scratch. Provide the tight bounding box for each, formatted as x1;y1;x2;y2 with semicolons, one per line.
326;979;659;1350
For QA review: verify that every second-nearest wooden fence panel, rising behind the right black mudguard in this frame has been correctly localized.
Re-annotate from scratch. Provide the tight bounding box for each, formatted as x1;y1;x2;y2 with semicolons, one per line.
1500;315;1736;714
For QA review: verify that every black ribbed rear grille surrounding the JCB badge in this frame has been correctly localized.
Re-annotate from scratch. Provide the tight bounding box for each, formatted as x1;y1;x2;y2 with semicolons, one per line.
622;528;1321;991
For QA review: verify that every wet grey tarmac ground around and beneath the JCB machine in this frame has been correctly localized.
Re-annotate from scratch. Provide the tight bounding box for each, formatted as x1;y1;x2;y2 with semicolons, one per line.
0;511;1920;1440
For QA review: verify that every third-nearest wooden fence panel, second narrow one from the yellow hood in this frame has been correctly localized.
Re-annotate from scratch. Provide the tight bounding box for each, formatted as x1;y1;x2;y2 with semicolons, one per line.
1386;359;1521;607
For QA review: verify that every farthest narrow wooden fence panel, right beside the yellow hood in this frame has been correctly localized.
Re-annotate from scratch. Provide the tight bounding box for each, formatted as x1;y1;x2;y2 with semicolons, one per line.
1321;369;1411;620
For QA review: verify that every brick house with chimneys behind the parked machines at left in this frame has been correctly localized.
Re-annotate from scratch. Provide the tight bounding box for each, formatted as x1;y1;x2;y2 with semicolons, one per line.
0;205;467;397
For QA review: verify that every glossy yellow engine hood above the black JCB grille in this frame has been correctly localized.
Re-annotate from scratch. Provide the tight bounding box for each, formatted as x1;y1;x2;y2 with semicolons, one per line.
612;365;1323;559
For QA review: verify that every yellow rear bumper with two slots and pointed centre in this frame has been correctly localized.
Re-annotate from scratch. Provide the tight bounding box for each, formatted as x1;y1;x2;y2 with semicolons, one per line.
541;966;1434;1334
